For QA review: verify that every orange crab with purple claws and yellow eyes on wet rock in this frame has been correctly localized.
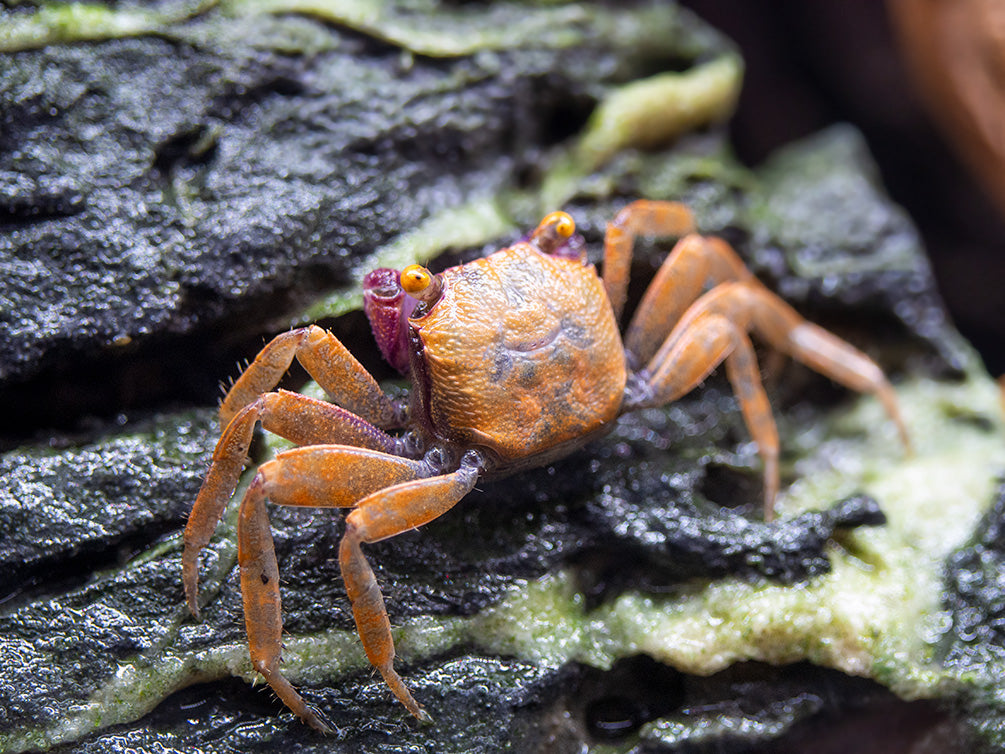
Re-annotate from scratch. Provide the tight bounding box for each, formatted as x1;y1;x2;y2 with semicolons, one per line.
183;200;907;731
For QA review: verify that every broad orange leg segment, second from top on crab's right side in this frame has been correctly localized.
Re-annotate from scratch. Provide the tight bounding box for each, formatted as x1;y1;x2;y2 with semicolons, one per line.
624;233;754;365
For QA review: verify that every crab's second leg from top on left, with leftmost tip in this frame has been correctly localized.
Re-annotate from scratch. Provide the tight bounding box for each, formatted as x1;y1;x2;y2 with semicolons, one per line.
182;390;395;615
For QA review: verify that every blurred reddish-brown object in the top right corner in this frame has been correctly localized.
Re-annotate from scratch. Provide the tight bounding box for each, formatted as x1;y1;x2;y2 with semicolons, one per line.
887;0;1005;213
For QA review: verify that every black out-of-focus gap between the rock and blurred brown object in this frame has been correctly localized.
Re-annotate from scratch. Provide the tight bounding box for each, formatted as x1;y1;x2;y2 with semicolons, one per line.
678;0;1005;375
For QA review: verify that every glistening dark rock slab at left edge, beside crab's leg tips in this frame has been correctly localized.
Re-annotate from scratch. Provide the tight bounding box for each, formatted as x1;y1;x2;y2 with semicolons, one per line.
0;409;217;601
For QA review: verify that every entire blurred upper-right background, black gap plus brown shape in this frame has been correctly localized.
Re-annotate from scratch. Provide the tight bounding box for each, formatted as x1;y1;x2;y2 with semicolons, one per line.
681;0;1005;376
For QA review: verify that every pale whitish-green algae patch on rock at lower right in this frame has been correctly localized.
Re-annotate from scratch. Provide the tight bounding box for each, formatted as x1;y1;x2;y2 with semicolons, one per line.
472;376;1005;699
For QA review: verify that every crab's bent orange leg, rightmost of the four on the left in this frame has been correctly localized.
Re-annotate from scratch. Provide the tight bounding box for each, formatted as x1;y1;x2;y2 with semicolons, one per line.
339;453;479;722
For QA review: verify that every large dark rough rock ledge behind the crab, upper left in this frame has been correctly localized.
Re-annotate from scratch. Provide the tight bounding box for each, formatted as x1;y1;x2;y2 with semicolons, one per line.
0;2;710;428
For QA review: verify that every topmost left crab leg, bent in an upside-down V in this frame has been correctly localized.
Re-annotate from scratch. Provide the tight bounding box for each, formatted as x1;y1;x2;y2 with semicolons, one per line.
220;325;395;427
